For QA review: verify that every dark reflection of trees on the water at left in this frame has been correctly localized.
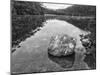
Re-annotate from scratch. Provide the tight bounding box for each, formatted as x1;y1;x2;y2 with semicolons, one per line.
12;16;44;46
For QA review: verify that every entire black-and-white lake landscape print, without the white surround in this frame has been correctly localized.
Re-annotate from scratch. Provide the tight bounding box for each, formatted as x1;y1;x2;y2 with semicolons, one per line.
10;0;96;75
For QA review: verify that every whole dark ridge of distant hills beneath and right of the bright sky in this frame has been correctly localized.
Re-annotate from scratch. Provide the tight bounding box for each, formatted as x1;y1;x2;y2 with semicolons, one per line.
43;5;96;16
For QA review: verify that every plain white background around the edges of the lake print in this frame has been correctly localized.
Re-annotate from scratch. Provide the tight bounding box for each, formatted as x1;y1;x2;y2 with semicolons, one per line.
0;0;100;75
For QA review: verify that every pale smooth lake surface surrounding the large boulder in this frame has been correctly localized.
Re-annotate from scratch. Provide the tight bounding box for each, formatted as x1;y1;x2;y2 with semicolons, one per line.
11;15;94;73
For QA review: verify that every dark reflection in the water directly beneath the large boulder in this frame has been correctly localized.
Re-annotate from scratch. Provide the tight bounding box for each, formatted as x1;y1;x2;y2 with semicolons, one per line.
48;53;75;68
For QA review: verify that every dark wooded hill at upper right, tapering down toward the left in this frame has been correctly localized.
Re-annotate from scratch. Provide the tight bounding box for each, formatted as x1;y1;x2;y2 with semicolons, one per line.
57;5;96;16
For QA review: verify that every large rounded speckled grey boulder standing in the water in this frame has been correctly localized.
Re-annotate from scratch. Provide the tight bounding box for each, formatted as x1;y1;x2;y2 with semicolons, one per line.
48;35;76;56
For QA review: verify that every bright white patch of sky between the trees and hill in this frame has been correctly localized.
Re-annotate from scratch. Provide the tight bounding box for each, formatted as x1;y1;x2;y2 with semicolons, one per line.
43;3;72;10
